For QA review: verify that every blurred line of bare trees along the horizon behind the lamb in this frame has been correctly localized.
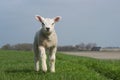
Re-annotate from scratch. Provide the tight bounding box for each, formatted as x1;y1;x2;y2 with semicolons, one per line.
1;43;101;51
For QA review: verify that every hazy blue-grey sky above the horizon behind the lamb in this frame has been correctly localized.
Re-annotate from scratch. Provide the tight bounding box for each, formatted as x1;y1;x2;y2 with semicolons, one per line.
0;0;120;47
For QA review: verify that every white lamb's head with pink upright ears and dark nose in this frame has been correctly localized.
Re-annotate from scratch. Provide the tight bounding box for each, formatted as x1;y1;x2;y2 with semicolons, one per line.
35;15;61;35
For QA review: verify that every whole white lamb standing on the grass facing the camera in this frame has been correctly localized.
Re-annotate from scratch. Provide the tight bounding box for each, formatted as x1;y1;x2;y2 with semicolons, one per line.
33;16;61;72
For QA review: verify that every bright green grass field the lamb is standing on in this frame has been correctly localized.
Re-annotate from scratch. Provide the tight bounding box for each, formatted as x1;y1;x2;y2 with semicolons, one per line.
0;50;120;80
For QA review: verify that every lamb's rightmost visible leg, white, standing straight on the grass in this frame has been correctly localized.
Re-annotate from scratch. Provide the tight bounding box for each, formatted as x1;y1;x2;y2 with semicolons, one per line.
49;47;57;72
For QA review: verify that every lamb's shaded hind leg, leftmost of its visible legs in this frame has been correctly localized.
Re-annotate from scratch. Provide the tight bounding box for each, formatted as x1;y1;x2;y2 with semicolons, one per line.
34;46;40;71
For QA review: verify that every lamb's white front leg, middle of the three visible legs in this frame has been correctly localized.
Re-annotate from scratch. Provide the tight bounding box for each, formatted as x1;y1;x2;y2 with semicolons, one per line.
39;46;47;72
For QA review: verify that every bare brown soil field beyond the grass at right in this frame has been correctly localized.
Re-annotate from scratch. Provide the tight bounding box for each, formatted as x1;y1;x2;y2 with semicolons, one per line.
63;51;120;59
